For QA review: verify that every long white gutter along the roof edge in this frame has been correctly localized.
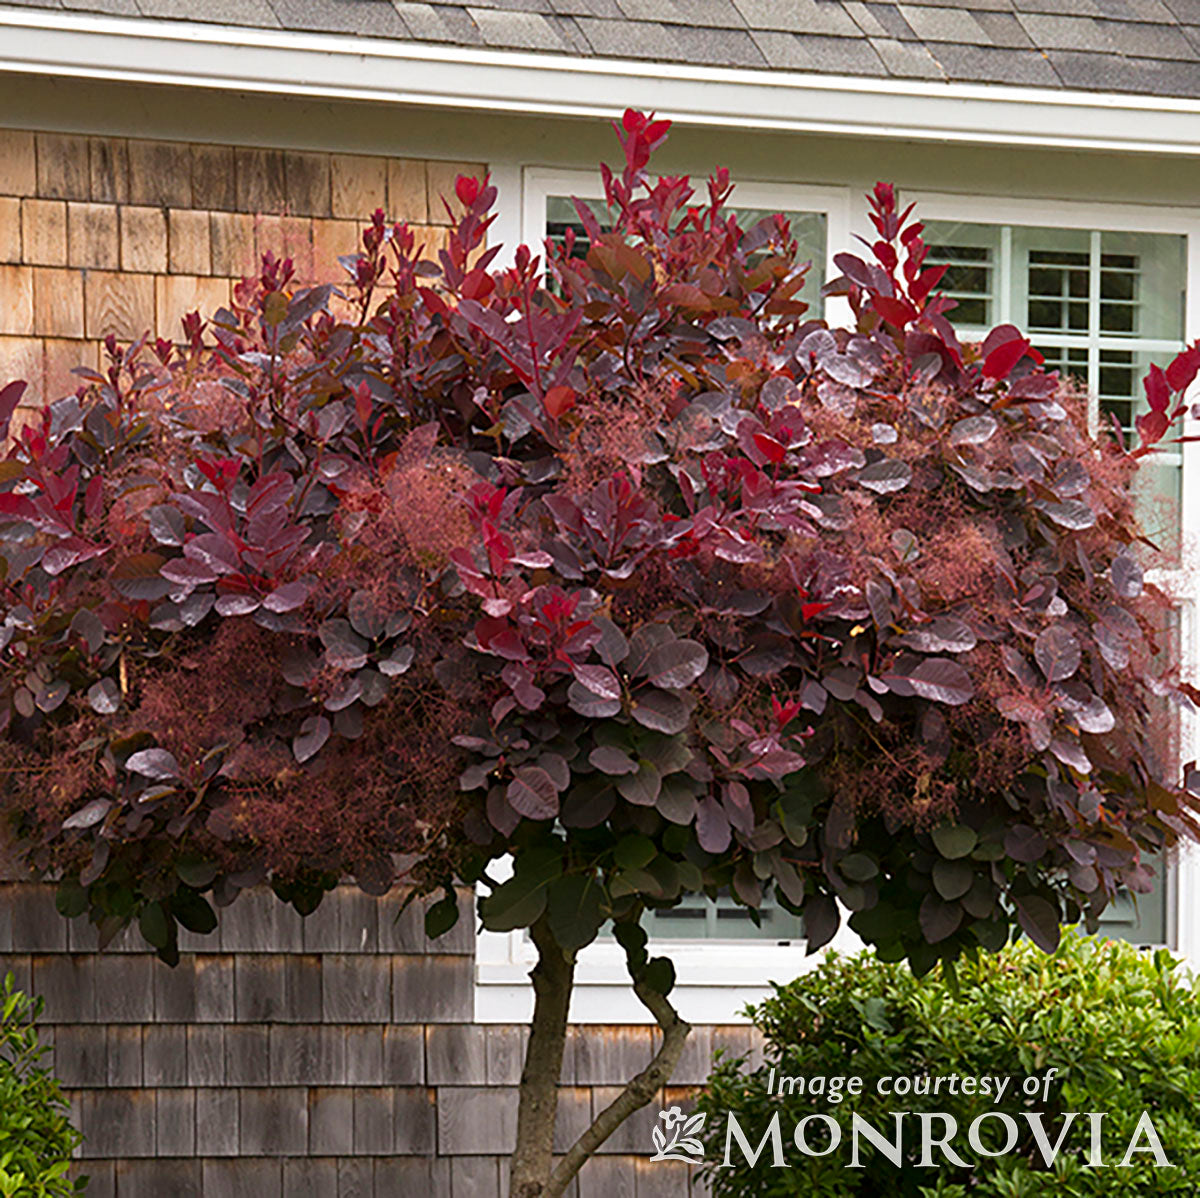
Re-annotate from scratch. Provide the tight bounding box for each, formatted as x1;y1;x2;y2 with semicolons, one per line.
0;8;1200;156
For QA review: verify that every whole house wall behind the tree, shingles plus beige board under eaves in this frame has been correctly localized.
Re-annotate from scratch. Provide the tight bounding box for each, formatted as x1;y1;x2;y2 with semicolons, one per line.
0;77;1200;1198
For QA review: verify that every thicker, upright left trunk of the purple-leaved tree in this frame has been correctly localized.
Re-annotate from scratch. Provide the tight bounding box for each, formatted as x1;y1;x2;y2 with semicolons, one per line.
509;916;575;1198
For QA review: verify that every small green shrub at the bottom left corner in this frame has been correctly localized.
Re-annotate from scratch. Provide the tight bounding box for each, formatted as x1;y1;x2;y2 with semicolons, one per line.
0;974;86;1198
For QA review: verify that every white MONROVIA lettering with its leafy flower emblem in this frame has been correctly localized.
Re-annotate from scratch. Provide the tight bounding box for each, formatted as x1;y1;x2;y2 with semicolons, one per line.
650;1107;1175;1169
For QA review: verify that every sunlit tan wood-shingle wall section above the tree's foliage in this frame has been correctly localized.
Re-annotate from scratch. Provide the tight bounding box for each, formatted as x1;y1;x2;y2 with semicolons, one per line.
0;128;484;422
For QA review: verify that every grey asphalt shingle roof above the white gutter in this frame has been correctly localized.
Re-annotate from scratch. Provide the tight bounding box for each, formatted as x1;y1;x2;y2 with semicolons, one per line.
2;0;1200;97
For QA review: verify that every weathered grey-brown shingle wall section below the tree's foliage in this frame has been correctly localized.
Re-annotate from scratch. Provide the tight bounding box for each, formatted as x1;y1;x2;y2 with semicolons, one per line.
0;881;756;1198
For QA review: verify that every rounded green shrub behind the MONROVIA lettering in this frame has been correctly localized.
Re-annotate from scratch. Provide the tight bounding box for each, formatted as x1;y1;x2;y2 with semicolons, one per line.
700;936;1200;1198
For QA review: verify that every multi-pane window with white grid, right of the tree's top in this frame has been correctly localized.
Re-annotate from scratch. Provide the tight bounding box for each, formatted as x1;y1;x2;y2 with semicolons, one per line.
925;221;1187;553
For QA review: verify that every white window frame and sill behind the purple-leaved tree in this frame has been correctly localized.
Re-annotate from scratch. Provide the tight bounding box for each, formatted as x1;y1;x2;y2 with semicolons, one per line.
475;177;1200;1024
